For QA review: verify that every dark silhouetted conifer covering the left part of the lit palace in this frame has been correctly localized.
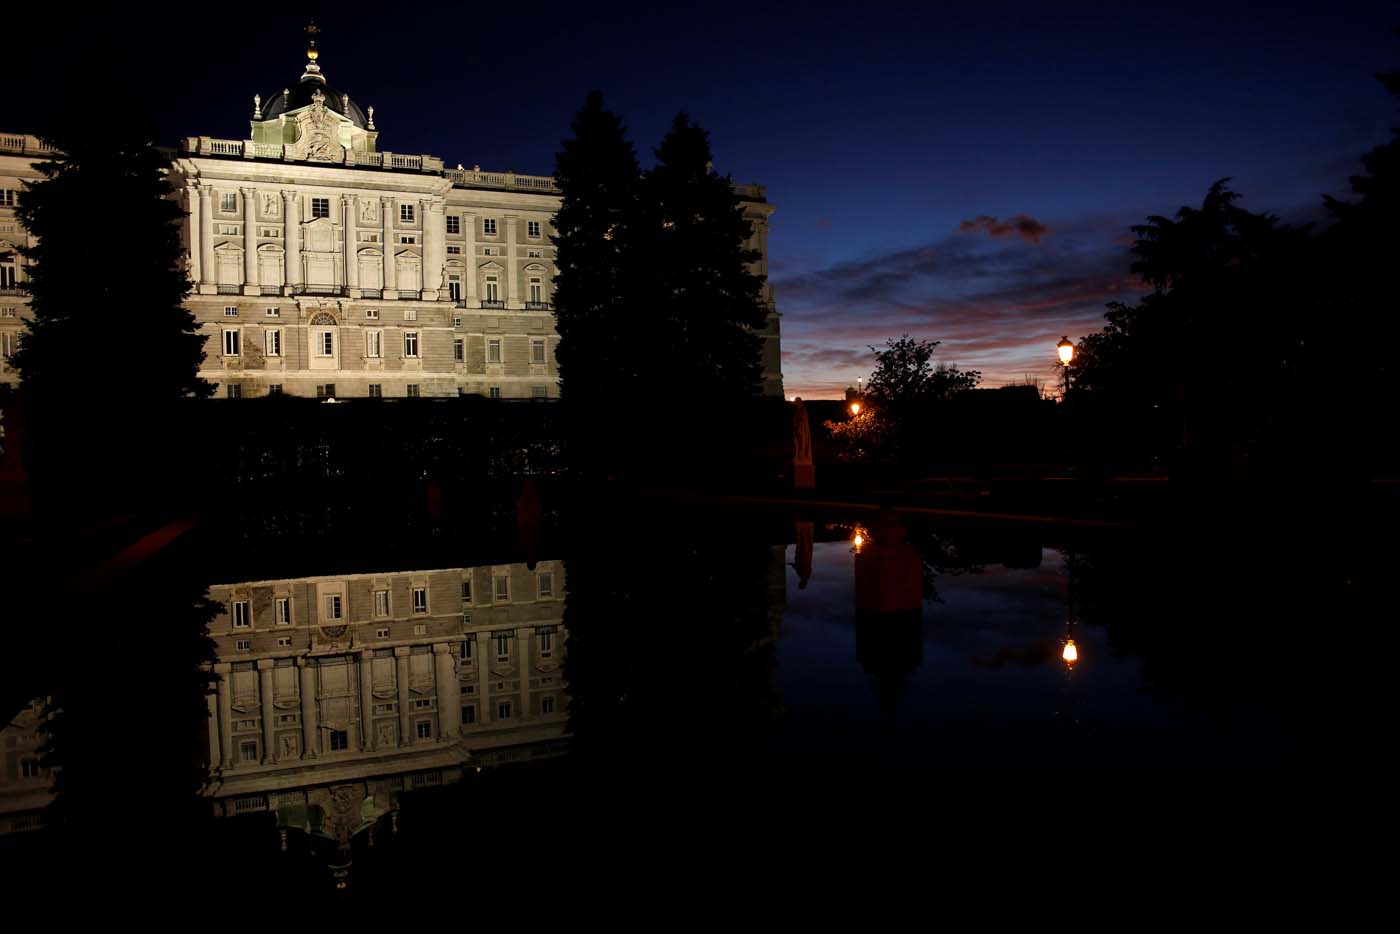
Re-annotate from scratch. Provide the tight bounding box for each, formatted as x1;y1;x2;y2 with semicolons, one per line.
14;125;213;515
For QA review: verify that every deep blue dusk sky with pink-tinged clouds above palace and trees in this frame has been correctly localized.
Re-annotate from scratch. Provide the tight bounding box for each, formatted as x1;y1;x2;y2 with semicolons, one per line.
13;0;1400;398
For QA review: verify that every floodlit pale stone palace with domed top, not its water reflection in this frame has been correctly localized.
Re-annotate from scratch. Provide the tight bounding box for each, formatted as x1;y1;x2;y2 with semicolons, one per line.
0;29;783;399
